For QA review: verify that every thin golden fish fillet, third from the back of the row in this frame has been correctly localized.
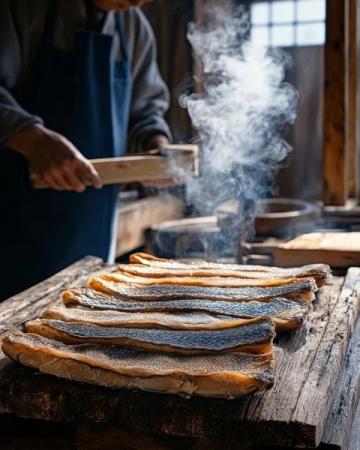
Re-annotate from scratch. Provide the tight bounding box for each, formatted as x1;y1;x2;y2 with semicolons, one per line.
101;272;304;288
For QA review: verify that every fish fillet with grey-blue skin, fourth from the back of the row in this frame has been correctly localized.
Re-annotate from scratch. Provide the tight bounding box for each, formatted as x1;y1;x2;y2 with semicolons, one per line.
88;277;317;302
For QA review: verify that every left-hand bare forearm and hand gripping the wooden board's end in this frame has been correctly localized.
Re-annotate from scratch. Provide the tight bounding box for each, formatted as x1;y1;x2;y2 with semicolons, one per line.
5;123;102;192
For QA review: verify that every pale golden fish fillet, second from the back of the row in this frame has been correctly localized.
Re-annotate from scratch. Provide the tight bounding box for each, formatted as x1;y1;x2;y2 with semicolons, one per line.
118;261;329;287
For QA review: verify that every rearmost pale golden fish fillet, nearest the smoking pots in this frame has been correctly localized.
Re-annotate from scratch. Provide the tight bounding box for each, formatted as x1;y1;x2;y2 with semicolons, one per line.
128;253;331;287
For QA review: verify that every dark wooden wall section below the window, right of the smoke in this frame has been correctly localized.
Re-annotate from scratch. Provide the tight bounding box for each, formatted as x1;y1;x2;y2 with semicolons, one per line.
278;46;324;200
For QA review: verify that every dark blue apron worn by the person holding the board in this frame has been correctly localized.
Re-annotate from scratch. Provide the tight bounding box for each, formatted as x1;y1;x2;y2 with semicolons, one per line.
0;1;131;300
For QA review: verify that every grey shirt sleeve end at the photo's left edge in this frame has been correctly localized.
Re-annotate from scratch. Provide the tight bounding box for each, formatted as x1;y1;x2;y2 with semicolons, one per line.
0;86;42;145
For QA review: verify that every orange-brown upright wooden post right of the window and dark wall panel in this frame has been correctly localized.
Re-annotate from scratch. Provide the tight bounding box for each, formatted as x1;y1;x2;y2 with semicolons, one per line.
323;0;349;205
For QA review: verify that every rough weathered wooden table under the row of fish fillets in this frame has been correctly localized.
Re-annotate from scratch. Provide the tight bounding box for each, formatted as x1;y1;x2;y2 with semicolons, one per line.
0;257;360;450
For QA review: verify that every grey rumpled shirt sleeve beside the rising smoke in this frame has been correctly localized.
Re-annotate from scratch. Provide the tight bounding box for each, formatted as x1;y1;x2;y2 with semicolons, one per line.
128;9;171;152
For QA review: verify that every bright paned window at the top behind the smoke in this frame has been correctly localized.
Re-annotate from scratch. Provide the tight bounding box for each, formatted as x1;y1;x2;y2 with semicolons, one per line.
250;0;326;47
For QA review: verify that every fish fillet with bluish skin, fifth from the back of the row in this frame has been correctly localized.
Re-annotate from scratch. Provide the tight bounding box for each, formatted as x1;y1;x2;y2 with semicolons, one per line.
62;288;308;330
